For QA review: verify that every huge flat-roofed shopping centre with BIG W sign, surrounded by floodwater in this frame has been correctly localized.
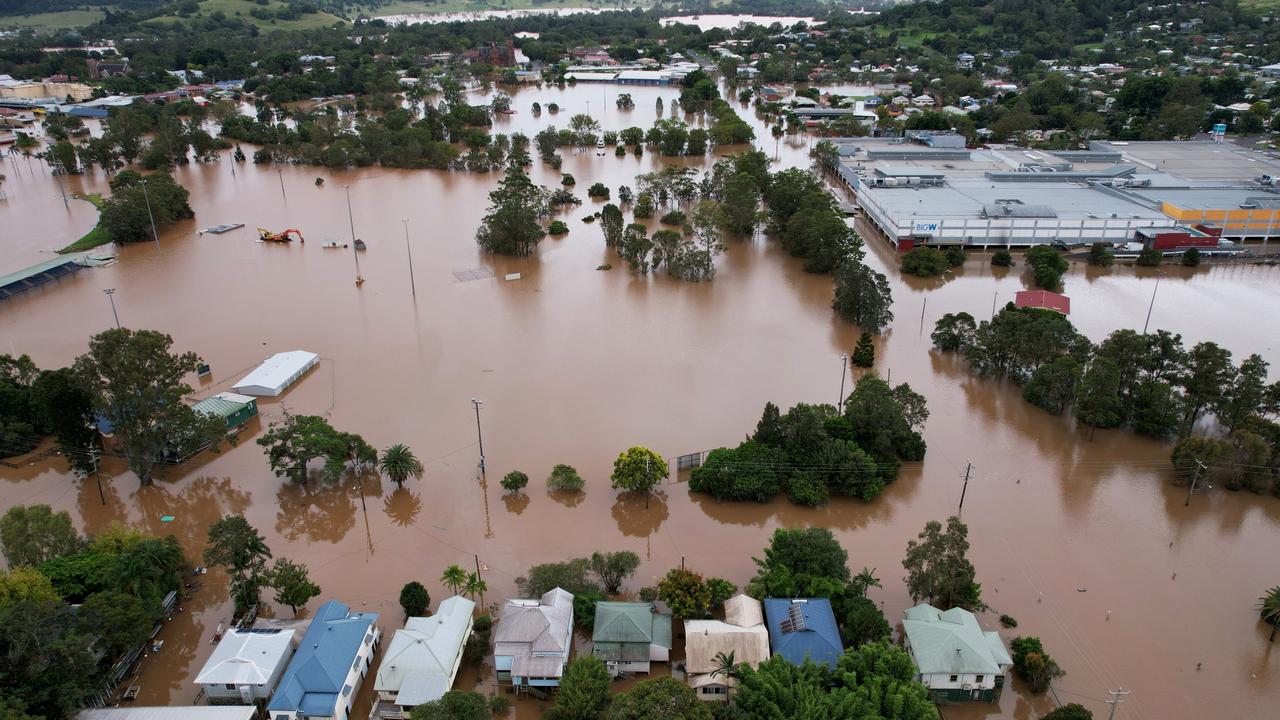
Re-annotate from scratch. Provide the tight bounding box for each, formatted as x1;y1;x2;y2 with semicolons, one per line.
837;139;1280;250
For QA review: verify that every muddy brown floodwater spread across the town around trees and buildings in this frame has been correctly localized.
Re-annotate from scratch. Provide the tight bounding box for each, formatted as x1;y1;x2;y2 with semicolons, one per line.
0;78;1280;720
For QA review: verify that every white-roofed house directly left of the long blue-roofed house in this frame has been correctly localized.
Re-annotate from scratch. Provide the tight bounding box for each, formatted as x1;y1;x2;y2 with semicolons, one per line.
196;629;298;705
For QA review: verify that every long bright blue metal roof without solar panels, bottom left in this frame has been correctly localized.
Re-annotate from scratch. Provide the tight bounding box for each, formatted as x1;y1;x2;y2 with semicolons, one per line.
266;600;378;717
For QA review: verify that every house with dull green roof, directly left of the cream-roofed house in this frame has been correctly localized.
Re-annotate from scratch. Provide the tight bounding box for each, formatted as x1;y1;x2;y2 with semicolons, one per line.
591;602;671;675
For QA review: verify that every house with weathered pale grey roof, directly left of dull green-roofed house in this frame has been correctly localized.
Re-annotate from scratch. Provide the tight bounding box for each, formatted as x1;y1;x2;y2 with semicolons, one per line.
493;588;573;688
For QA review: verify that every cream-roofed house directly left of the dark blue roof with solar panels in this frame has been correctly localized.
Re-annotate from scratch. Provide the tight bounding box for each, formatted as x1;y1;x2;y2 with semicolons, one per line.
685;594;769;701
